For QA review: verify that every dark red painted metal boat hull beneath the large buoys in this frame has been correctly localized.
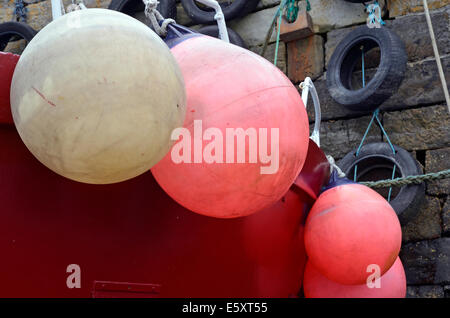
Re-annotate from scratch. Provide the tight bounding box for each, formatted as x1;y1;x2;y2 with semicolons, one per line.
0;51;329;297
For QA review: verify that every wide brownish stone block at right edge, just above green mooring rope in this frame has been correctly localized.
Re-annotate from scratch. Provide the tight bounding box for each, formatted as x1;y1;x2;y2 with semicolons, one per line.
384;106;450;152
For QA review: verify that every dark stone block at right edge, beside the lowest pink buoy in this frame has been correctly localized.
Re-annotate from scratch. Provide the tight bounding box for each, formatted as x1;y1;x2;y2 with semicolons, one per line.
400;237;450;285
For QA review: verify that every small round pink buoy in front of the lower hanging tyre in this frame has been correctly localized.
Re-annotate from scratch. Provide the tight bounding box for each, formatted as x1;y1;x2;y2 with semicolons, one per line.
305;184;402;285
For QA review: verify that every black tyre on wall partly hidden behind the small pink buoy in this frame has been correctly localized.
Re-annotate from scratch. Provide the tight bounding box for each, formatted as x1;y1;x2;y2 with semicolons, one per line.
338;142;425;225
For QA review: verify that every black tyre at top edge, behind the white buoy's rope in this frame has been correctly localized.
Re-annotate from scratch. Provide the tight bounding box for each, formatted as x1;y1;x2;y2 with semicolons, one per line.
108;0;177;19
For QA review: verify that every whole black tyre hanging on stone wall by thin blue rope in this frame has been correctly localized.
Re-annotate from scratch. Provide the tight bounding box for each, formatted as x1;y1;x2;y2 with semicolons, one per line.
327;25;408;111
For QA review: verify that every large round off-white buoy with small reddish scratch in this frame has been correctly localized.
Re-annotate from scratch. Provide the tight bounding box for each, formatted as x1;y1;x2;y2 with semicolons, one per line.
11;9;186;184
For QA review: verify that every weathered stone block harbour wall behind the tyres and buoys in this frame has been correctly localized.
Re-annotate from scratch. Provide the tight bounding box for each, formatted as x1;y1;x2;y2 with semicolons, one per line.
0;0;450;297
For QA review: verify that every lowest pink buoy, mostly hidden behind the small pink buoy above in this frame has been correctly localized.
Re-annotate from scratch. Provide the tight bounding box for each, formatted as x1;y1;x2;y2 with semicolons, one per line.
303;257;406;298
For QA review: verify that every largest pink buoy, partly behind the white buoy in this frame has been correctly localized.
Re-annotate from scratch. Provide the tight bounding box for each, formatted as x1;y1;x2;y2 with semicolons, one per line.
152;36;309;218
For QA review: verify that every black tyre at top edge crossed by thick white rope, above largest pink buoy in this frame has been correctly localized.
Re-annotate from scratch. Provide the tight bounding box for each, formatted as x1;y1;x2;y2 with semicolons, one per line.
181;0;259;24
